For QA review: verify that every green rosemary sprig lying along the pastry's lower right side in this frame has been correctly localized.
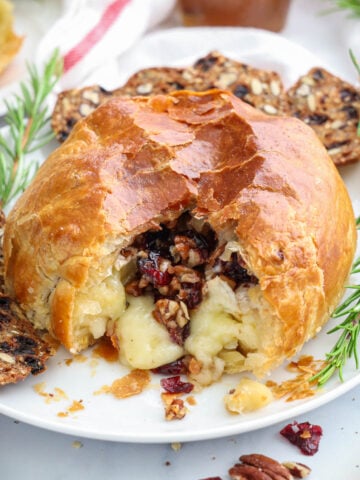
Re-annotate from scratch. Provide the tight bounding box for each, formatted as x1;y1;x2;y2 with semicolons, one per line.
310;217;360;386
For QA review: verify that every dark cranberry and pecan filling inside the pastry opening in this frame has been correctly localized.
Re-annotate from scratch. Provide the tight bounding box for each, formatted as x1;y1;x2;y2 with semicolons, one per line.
122;213;257;345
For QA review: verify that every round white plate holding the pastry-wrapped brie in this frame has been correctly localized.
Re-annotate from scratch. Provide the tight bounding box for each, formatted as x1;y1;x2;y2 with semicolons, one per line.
0;29;360;443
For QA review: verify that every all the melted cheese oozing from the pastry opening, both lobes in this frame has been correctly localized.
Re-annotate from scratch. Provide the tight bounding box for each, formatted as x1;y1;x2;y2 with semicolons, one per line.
115;277;270;385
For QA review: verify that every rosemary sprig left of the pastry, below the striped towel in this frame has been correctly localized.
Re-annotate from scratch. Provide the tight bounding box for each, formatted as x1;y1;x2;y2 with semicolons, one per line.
0;50;62;209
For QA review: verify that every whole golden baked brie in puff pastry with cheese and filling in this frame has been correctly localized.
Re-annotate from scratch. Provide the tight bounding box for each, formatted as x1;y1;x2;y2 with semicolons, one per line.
4;90;356;384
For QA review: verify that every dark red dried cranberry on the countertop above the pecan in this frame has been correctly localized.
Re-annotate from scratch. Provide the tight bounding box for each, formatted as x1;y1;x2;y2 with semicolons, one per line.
280;422;323;455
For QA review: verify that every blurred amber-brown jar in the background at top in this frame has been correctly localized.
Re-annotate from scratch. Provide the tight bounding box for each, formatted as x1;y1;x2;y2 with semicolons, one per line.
179;0;290;32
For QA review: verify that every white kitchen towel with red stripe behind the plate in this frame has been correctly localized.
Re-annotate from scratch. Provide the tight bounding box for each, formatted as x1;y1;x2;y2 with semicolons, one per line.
36;0;175;90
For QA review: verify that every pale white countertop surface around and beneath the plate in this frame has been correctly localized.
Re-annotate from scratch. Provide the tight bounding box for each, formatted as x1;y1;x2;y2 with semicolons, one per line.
0;0;360;480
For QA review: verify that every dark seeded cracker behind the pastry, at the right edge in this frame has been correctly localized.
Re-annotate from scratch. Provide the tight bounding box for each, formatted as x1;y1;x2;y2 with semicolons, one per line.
287;67;360;165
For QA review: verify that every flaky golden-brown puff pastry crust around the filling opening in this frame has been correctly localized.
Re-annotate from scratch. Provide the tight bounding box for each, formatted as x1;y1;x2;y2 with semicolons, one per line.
4;90;356;383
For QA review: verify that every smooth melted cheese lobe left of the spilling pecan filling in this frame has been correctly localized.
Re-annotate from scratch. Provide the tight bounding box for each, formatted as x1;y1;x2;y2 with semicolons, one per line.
115;295;184;369
